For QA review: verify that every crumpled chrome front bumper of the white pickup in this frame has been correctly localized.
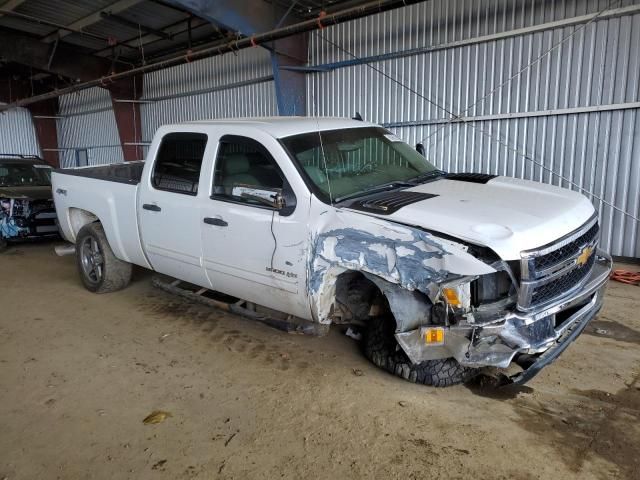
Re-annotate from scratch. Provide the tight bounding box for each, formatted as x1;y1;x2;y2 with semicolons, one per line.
396;251;611;383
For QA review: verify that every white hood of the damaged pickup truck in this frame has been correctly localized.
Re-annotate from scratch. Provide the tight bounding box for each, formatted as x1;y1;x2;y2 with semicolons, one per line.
350;177;594;260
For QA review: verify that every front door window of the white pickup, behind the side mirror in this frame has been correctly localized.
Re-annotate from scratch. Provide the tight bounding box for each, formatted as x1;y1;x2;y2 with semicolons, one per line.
212;135;285;207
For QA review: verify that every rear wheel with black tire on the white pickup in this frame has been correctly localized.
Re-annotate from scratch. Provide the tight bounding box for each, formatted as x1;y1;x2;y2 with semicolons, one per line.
76;222;132;293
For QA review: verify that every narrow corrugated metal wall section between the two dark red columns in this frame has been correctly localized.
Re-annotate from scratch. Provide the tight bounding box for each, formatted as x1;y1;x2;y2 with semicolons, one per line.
57;87;124;168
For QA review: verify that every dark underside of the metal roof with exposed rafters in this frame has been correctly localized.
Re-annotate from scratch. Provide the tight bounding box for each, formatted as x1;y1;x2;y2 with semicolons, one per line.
0;0;366;69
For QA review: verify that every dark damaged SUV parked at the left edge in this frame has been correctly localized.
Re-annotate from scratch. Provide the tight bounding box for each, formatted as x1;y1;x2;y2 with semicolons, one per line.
0;154;58;251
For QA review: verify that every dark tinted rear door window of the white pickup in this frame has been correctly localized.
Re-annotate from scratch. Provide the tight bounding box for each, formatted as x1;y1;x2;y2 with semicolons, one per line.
152;133;207;195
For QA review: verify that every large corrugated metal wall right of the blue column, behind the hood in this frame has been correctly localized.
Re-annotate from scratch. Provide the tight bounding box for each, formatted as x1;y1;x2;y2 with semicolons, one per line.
307;0;640;257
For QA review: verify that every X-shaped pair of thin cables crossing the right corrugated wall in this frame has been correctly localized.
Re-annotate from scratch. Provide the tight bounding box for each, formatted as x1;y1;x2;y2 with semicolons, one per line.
315;0;640;222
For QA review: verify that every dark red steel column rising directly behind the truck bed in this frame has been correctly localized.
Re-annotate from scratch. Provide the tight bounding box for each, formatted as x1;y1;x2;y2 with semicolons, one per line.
108;75;144;162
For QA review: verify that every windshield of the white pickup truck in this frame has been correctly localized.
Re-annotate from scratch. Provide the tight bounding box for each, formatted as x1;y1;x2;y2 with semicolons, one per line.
281;127;442;202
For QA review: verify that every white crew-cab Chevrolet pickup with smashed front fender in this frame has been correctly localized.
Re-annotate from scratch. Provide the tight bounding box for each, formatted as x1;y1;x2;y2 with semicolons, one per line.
52;117;611;386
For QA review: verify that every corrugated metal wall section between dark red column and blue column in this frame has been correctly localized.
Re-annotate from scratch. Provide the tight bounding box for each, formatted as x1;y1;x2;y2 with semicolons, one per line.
141;48;277;146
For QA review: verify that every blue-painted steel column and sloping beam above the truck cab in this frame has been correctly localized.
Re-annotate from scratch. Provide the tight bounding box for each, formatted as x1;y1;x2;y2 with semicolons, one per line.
169;0;309;115
